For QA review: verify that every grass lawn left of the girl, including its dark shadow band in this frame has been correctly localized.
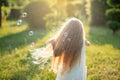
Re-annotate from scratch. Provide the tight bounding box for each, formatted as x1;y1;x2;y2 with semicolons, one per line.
0;22;54;80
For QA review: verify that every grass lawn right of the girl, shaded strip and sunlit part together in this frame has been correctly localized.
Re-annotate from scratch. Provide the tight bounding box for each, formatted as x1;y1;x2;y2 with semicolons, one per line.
87;27;120;80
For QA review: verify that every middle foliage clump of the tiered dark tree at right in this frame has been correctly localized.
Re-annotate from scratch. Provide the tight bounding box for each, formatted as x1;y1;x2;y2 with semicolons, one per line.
106;8;120;22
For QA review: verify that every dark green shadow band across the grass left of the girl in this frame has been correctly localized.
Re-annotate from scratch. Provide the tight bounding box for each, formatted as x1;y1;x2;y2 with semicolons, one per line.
0;29;49;54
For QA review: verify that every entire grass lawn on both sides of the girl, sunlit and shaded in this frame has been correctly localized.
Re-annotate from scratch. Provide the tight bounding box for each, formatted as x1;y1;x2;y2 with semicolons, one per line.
0;22;120;80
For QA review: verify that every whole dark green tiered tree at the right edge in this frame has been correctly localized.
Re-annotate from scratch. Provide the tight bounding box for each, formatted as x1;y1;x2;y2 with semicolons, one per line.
106;0;120;33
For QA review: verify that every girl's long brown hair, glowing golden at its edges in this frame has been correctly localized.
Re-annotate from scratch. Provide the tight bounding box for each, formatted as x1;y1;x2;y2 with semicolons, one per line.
51;18;84;74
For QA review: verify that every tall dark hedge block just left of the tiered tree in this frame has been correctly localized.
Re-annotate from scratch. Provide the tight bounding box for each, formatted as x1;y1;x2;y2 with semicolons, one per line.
90;0;108;25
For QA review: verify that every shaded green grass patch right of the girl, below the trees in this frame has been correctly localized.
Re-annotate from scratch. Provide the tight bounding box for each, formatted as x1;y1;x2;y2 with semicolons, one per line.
89;27;120;49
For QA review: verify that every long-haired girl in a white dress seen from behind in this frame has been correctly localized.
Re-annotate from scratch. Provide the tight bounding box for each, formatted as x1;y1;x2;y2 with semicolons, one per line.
50;18;89;80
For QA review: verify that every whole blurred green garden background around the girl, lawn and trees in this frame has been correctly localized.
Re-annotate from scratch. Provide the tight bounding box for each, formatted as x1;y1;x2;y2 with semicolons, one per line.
0;0;120;80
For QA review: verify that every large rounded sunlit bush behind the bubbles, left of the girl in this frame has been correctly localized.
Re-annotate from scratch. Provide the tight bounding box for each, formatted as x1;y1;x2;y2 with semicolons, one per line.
24;1;51;29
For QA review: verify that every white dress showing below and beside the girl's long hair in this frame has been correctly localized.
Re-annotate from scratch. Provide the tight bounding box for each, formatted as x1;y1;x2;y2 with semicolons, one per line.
56;43;87;80
